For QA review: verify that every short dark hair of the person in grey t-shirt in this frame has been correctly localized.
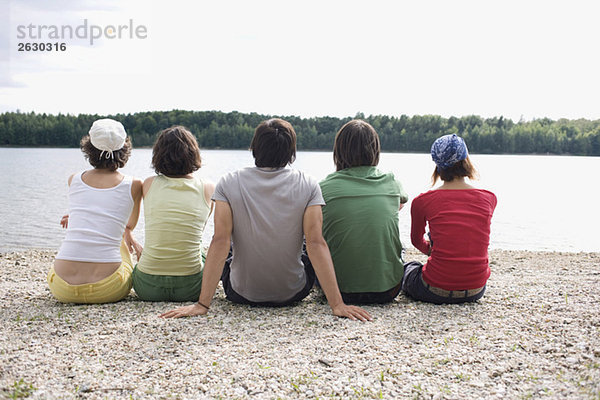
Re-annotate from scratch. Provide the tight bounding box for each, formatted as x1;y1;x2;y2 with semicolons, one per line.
250;118;296;168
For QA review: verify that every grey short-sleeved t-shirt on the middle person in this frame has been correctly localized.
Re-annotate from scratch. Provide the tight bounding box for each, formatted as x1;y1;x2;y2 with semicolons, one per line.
212;167;325;302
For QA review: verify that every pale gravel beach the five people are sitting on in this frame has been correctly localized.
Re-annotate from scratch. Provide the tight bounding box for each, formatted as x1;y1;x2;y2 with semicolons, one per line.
0;250;600;399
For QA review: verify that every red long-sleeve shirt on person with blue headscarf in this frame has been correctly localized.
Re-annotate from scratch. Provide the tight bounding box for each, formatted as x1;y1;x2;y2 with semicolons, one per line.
410;189;497;290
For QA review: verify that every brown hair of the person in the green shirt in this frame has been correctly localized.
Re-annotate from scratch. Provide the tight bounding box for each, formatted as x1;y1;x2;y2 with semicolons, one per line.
333;119;381;171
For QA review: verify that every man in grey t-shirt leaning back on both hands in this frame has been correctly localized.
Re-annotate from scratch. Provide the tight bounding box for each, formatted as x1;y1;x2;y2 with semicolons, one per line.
161;118;371;321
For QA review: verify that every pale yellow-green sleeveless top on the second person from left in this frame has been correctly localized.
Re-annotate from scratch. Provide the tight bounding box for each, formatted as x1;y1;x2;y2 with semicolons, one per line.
137;175;210;276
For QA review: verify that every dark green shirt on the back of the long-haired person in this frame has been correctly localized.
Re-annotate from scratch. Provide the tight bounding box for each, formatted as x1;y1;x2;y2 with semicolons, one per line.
321;167;407;297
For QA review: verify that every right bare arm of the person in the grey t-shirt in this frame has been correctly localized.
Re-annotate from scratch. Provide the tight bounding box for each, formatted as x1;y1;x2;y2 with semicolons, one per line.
303;206;372;321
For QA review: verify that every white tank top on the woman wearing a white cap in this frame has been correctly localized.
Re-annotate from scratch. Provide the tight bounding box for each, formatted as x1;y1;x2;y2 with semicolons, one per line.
56;172;133;262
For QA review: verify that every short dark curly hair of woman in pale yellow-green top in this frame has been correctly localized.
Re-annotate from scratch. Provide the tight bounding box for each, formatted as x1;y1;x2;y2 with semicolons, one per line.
152;125;202;176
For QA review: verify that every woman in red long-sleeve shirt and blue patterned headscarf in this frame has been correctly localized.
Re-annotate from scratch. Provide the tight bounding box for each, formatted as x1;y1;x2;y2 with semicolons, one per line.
402;135;497;304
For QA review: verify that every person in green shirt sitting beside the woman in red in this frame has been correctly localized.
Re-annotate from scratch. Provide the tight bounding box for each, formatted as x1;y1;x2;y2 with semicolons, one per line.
320;120;408;304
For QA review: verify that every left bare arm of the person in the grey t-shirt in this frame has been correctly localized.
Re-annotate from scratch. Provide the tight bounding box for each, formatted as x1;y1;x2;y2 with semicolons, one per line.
160;201;233;318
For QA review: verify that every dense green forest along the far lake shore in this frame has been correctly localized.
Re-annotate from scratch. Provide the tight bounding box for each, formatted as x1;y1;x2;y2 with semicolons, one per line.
0;110;600;156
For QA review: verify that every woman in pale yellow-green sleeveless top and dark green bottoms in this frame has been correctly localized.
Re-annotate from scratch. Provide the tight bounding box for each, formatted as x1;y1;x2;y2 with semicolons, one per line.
133;126;215;301
